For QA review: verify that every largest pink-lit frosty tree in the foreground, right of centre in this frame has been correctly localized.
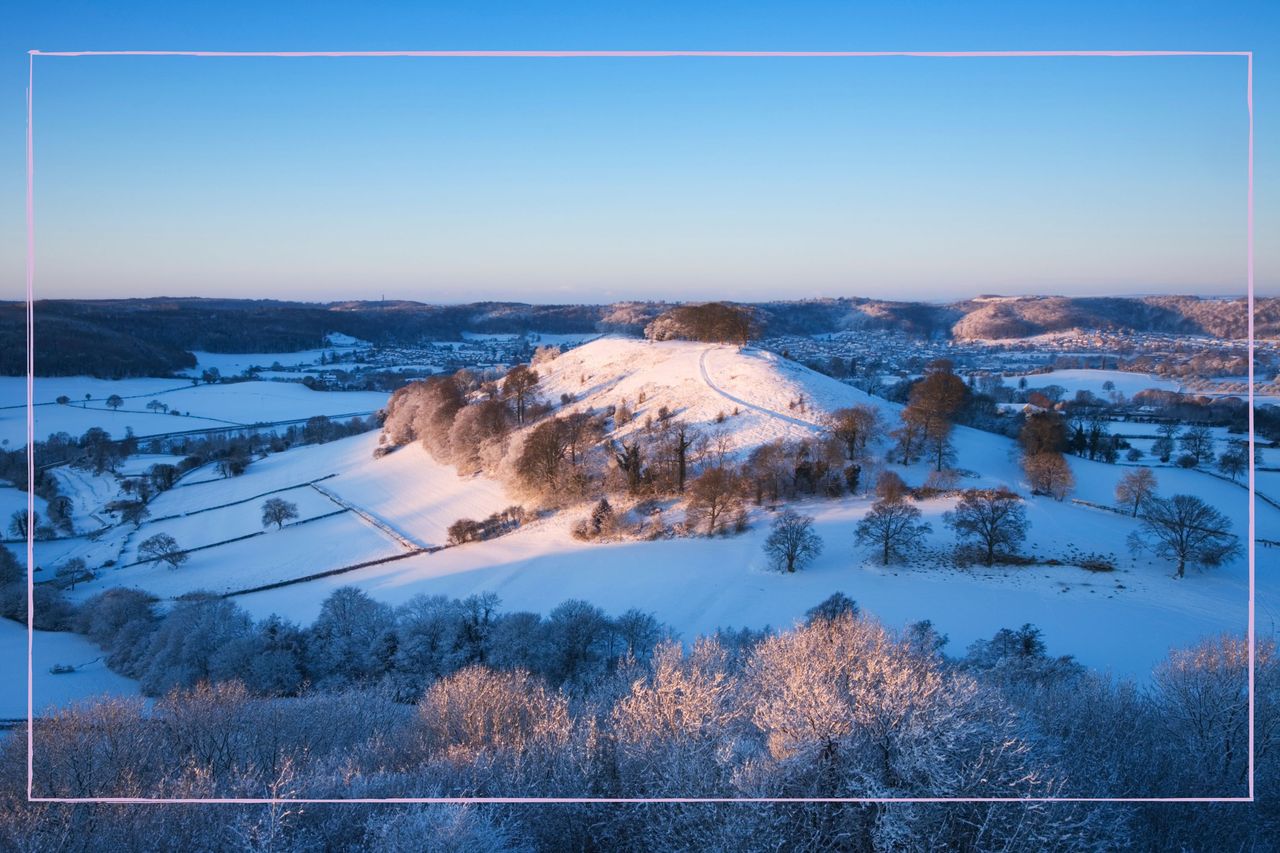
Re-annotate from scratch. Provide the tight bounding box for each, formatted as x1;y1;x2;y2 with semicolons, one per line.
746;607;1046;809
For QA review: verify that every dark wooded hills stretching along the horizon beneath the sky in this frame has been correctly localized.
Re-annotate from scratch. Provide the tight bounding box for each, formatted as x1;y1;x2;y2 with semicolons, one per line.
0;296;1280;378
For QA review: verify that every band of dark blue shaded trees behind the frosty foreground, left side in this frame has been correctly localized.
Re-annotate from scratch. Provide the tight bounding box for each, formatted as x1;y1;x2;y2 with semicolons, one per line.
64;587;668;702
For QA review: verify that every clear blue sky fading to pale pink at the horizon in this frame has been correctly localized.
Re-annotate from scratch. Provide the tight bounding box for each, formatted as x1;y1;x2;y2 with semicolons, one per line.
0;3;1280;302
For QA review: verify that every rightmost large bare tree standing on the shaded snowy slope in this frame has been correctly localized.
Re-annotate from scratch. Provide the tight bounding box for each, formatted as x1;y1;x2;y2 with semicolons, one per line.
1129;494;1240;578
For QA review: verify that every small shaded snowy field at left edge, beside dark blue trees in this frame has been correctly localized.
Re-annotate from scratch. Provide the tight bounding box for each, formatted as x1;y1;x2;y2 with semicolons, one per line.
0;619;138;720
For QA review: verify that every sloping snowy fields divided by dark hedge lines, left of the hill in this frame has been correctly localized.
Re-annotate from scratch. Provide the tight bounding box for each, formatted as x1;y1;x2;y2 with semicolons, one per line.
56;433;512;598
